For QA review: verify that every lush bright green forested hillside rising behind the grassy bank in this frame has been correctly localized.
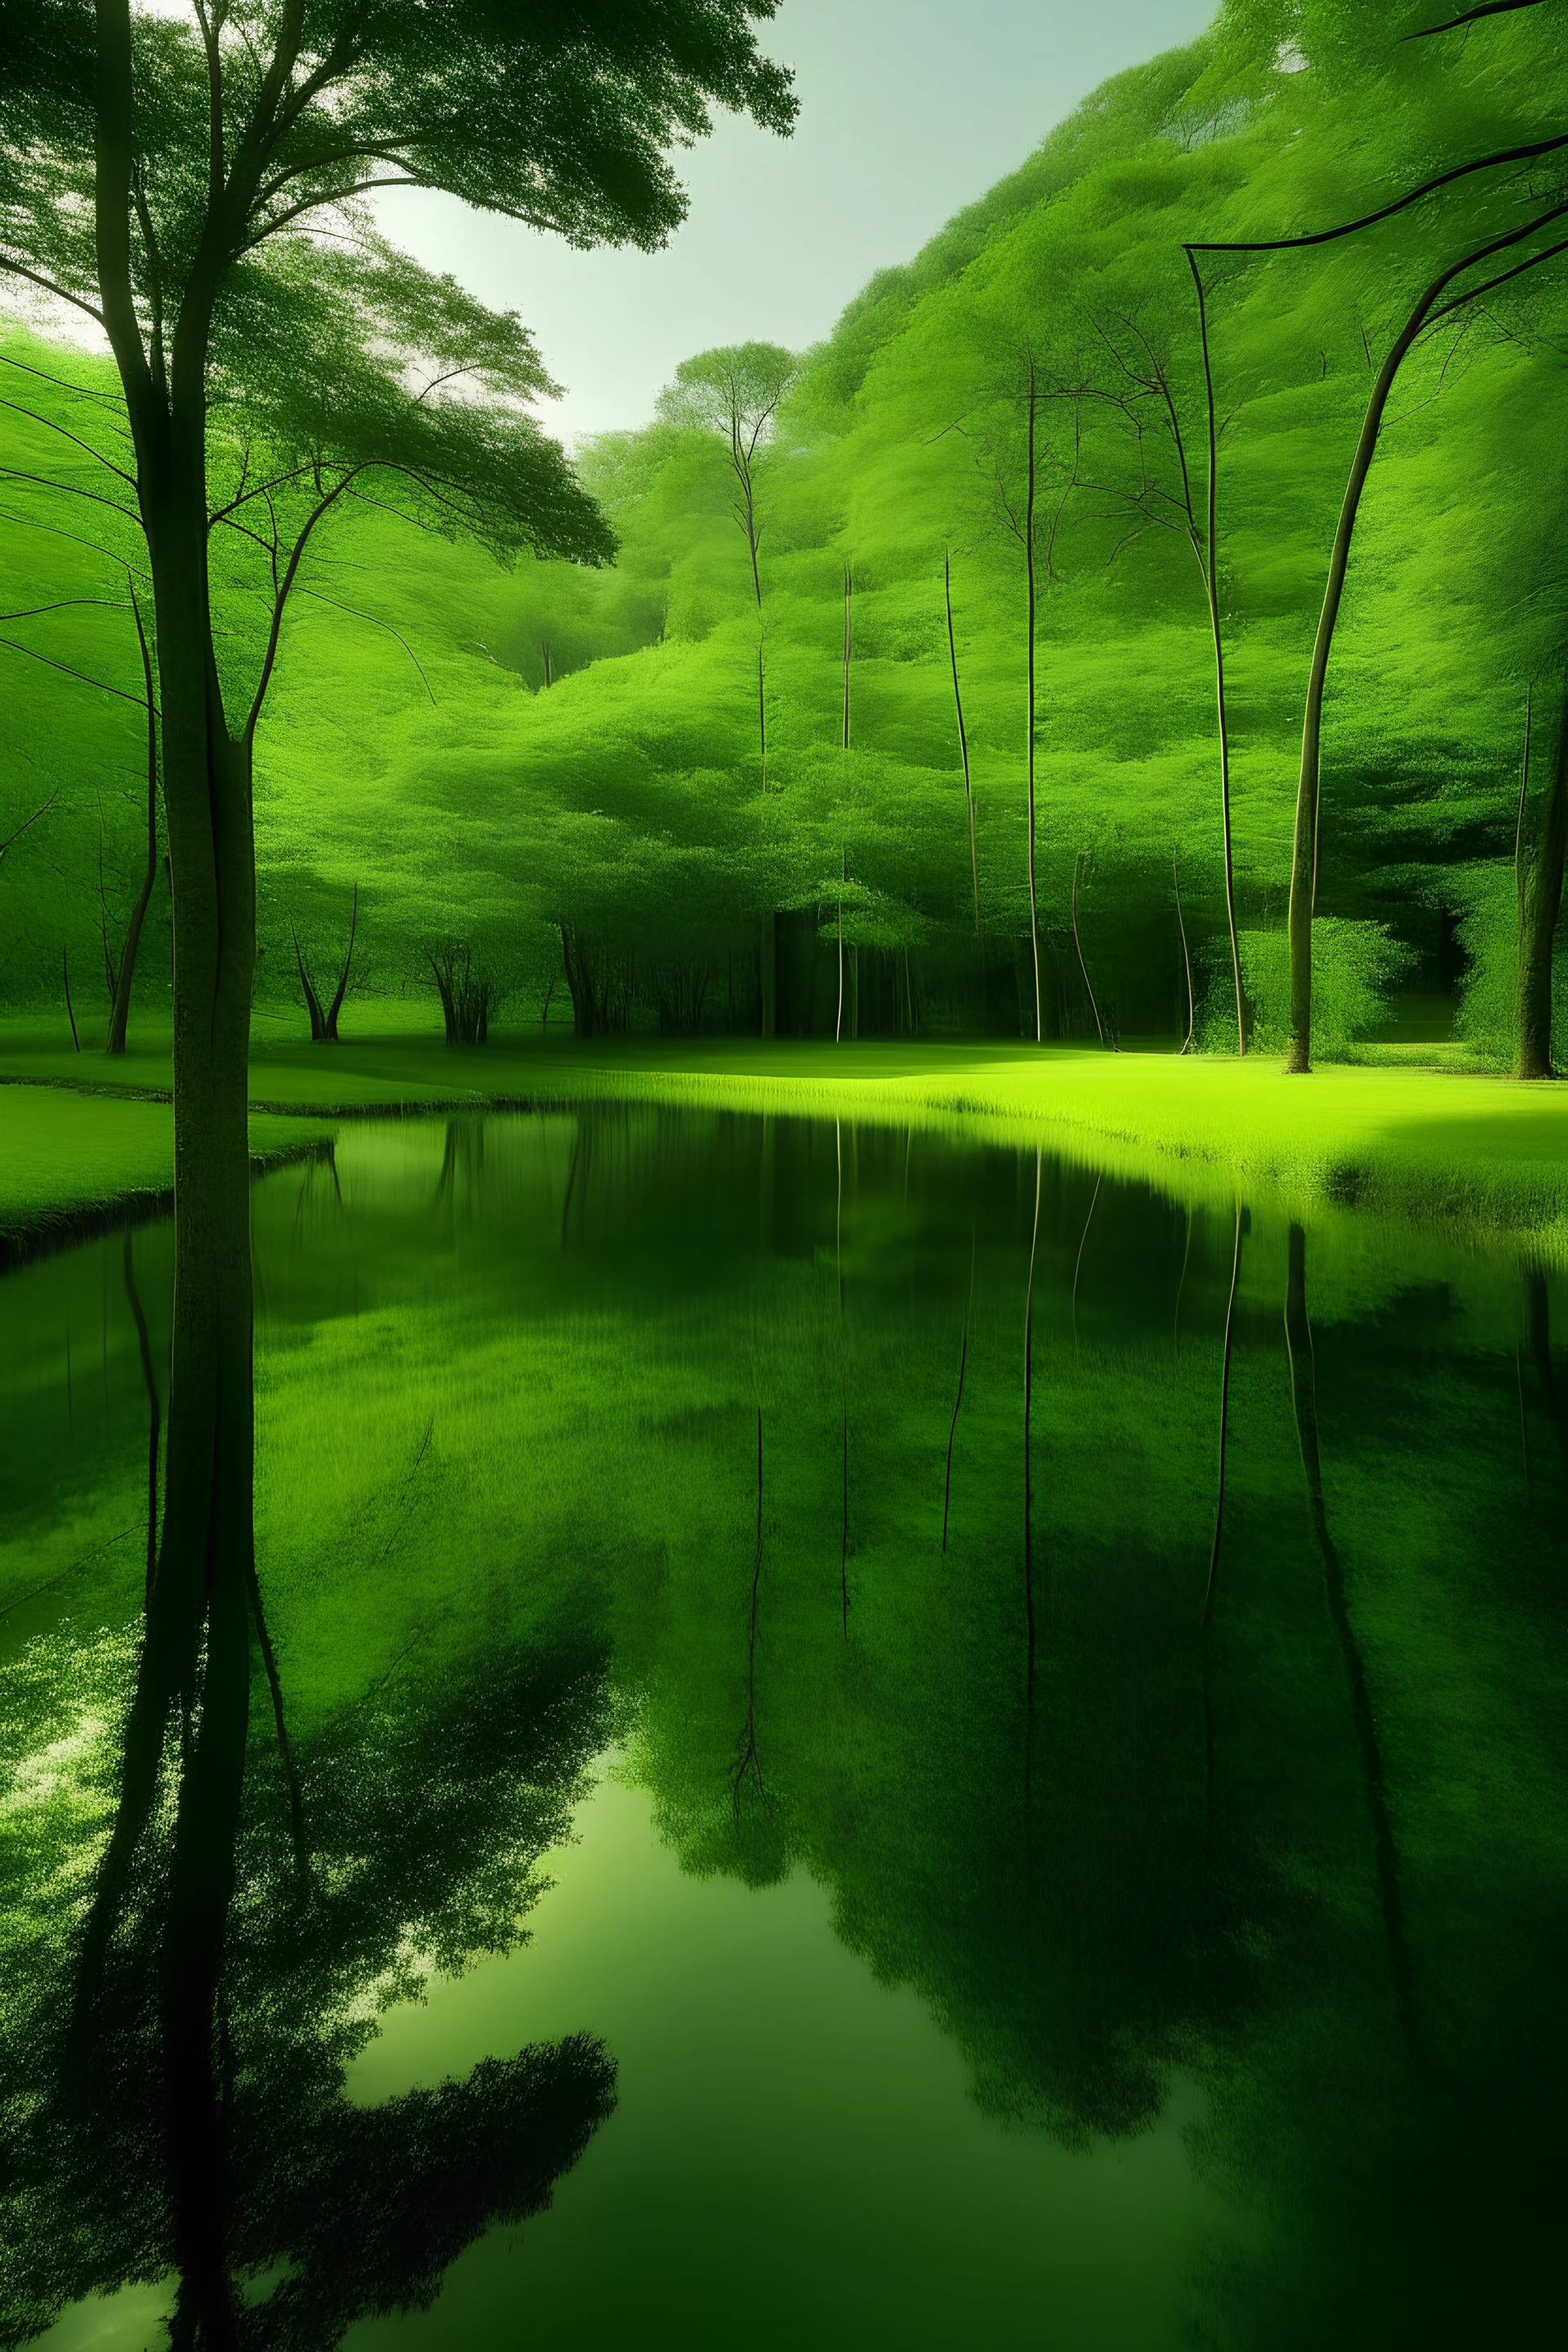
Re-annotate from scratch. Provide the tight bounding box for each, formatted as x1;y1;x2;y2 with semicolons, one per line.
0;0;1568;1058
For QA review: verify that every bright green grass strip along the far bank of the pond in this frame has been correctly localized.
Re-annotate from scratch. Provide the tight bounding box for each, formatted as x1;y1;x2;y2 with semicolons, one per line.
0;1007;1568;1249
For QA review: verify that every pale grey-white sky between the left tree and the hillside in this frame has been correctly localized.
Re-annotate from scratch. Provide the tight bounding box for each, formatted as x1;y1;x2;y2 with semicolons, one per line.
378;0;1215;438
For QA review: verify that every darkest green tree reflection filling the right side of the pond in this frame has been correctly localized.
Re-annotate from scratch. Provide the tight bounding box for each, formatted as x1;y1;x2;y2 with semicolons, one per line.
642;1155;1563;2352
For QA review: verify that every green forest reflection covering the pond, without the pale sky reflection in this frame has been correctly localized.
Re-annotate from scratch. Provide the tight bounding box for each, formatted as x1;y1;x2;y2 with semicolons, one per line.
0;1110;1568;2347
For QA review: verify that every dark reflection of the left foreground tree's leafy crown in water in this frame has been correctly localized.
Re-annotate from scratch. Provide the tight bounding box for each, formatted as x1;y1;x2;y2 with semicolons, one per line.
0;1646;613;2352
